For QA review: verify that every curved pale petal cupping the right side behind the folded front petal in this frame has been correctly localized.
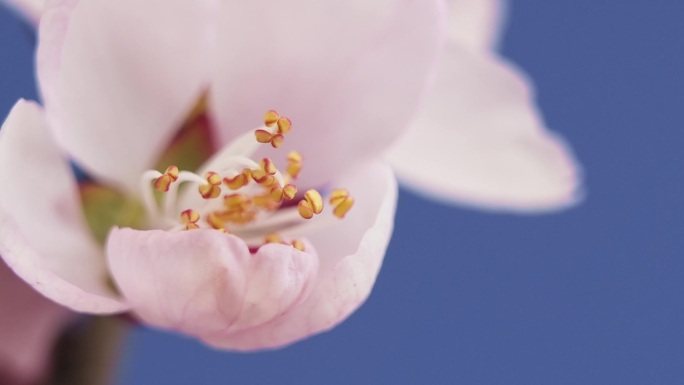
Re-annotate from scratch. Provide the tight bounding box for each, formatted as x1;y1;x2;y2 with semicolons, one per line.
203;163;397;350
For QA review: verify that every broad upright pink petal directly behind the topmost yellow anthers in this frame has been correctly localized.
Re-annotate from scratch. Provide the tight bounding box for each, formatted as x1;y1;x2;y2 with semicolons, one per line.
212;0;443;189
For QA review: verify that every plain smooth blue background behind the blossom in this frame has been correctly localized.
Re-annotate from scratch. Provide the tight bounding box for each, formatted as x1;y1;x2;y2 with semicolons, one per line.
0;0;684;385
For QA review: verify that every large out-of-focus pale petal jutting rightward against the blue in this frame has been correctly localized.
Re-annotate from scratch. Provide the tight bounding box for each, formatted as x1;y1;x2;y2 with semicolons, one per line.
389;44;582;211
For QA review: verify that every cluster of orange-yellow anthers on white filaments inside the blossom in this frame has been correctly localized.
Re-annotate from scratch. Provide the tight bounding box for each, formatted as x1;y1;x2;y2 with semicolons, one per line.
138;110;354;251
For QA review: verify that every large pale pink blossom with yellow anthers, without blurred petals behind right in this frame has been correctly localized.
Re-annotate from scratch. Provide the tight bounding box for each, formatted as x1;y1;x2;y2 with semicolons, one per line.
0;0;443;350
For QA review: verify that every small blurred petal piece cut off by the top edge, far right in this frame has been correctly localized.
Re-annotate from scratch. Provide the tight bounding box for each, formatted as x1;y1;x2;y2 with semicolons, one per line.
447;0;508;50
